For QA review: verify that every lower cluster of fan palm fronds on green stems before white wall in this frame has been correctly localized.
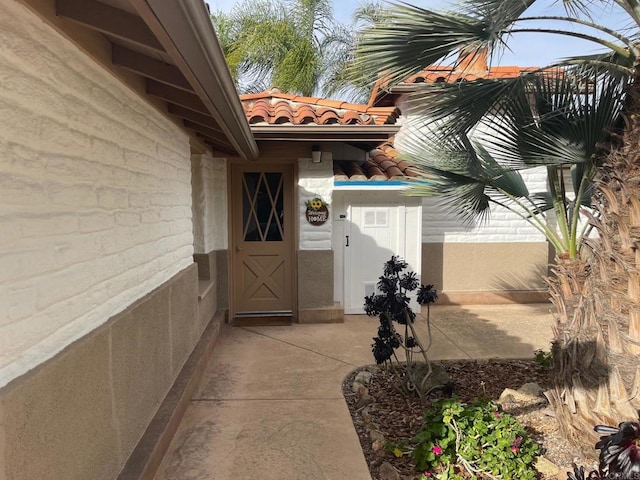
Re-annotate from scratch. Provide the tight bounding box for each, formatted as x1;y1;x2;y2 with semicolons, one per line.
396;69;625;260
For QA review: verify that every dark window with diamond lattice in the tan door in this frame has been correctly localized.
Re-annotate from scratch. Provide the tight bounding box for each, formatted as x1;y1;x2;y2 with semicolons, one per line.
242;172;284;242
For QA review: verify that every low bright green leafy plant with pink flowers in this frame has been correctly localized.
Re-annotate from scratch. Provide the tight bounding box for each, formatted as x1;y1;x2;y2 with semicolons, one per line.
405;398;540;480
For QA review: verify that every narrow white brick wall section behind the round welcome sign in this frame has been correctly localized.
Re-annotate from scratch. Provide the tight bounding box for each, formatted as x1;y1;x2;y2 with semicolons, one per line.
298;153;333;250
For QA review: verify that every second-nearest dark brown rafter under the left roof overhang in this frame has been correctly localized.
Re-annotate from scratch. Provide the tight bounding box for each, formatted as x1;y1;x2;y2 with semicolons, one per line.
111;44;194;93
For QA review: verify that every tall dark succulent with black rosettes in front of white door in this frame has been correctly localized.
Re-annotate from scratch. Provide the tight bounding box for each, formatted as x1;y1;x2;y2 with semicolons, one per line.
364;255;439;396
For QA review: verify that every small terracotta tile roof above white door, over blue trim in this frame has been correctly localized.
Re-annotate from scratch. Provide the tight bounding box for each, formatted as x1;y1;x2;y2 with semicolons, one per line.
333;143;419;181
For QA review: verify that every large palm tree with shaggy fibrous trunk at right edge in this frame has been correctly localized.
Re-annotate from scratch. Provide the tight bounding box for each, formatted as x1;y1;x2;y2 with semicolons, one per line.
357;0;640;448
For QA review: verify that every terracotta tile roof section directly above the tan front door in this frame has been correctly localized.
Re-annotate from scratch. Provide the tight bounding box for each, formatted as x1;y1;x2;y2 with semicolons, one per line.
240;89;398;125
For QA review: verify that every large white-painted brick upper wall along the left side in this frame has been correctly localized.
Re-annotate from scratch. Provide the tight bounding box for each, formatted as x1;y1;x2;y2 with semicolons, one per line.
0;1;193;386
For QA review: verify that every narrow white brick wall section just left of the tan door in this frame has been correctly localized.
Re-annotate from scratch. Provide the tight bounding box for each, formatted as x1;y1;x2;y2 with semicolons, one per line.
191;153;228;253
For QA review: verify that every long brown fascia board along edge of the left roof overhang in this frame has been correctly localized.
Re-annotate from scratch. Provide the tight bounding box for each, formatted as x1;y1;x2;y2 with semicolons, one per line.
131;0;259;160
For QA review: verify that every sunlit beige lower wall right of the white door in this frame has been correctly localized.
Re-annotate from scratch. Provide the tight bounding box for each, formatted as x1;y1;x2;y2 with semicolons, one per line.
422;242;549;303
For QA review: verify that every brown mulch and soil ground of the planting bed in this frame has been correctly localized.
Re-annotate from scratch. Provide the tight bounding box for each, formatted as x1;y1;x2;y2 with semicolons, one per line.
343;360;595;480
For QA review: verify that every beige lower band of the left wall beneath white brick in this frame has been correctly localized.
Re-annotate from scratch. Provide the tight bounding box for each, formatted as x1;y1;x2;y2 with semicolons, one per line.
0;265;205;480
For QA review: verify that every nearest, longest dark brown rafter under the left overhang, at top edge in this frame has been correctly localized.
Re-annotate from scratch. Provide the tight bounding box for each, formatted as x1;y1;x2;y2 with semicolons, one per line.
56;0;165;52
